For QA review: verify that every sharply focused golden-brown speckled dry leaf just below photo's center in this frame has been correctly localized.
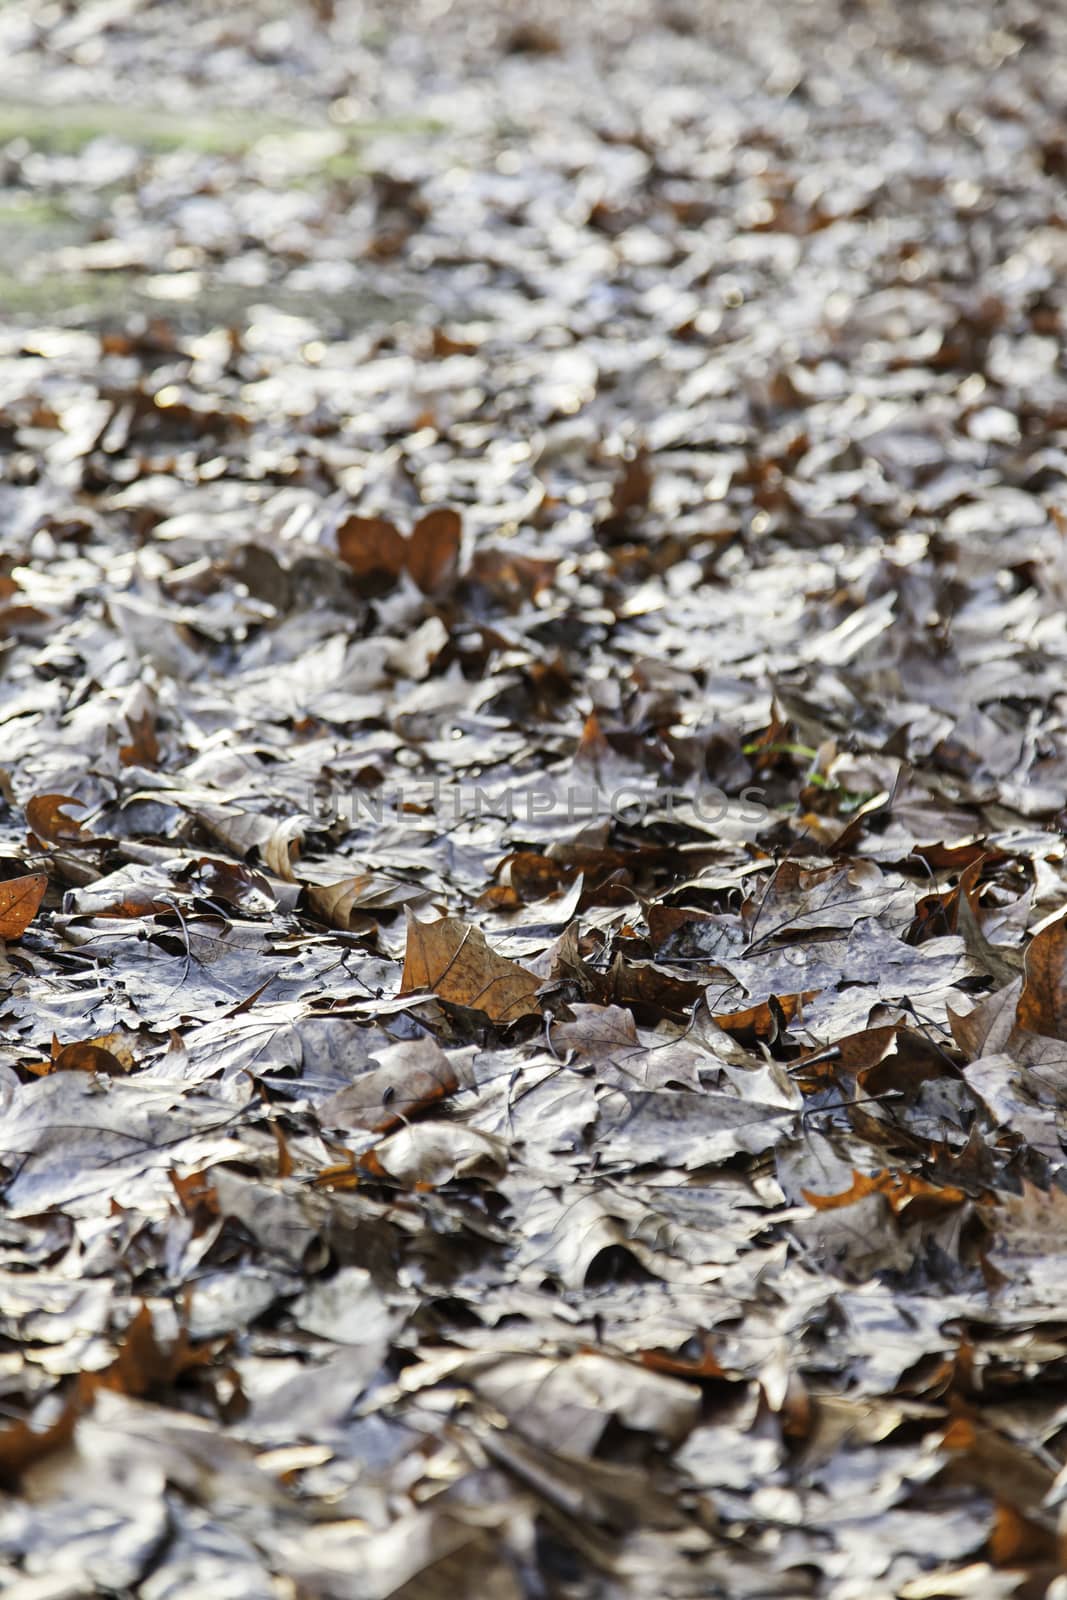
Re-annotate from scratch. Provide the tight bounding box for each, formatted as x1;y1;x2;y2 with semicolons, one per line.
400;912;539;1022
